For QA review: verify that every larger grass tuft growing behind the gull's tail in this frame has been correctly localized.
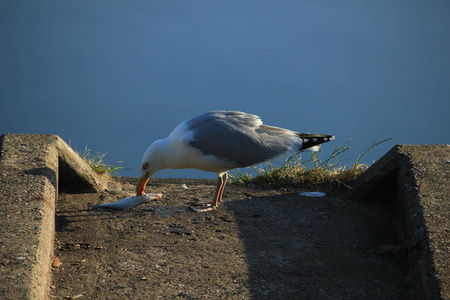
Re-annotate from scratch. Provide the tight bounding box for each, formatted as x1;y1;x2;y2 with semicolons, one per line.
234;139;391;186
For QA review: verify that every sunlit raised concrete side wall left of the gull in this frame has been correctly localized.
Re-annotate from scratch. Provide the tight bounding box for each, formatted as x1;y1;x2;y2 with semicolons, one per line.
0;134;106;299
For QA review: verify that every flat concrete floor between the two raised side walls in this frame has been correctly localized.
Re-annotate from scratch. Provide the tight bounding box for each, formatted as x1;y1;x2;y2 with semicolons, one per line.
51;178;412;300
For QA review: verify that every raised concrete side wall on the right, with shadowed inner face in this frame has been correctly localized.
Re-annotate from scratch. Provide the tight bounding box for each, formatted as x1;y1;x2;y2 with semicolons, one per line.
351;145;450;299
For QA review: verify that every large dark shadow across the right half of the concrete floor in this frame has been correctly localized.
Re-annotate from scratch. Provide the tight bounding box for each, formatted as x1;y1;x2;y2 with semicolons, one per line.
225;193;412;299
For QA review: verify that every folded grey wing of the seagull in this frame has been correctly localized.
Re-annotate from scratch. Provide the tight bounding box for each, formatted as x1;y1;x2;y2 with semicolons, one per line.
186;111;301;167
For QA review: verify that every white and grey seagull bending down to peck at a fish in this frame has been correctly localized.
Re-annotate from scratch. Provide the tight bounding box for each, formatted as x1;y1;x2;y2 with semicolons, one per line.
136;110;334;212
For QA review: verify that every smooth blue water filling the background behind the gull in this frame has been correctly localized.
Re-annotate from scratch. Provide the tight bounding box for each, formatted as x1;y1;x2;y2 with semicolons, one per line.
0;1;450;178
